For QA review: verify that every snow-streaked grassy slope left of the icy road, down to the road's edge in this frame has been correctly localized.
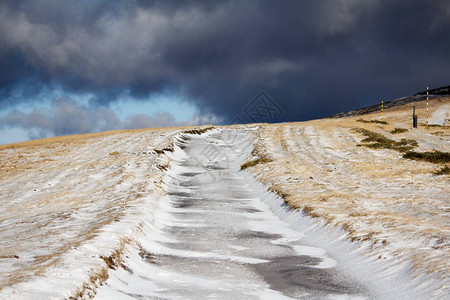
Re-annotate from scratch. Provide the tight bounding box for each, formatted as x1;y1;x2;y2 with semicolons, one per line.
0;130;179;299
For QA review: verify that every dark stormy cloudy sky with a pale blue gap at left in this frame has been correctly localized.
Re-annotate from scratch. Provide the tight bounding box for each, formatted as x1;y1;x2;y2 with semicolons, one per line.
0;0;450;144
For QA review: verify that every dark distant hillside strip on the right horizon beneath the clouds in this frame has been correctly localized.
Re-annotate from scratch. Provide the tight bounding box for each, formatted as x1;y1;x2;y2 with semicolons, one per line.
328;85;450;119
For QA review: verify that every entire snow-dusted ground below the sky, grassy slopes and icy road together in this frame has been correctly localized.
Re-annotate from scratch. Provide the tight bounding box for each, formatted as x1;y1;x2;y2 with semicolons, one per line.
0;98;450;299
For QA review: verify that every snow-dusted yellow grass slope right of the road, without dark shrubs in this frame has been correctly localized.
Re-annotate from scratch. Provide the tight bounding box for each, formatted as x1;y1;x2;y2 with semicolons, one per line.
244;98;450;296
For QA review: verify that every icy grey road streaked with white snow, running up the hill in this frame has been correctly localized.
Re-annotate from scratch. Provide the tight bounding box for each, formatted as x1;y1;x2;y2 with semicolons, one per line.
96;130;380;299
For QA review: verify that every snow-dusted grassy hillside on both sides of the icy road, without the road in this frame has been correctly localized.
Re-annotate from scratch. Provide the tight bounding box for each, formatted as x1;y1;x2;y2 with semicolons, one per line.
0;97;450;299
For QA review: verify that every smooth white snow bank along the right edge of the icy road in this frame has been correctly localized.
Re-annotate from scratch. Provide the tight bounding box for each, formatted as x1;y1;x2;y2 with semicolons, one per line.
243;172;446;299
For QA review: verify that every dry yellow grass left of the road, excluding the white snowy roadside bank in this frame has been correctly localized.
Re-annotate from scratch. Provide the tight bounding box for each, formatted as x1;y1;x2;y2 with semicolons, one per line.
0;127;198;290
